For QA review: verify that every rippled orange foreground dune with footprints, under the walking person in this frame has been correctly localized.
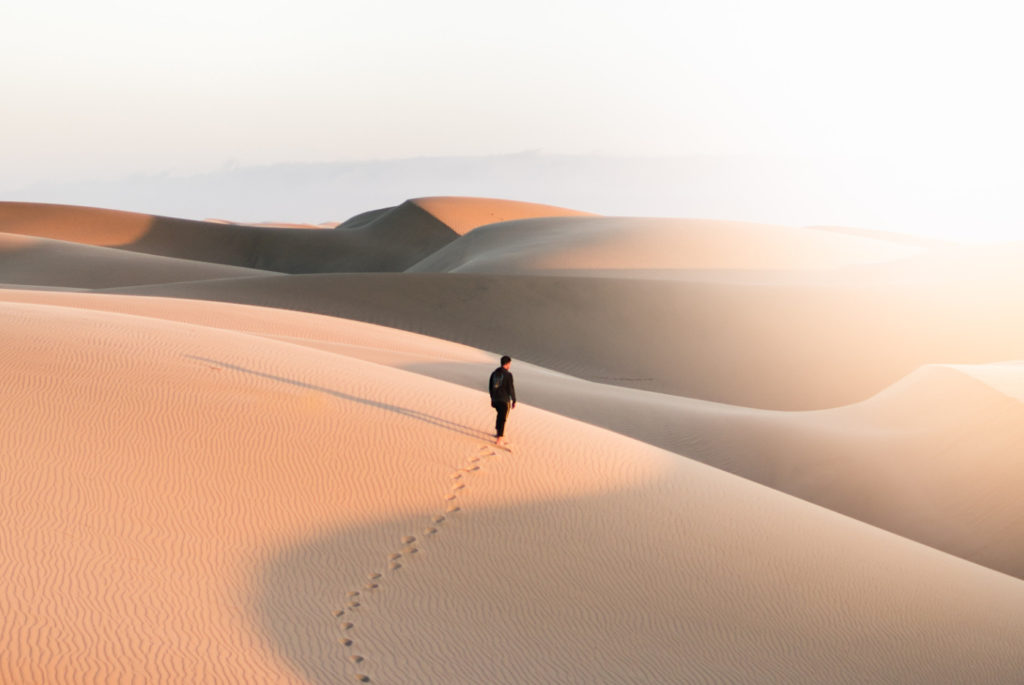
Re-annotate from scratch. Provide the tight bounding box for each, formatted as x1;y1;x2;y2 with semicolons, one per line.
0;295;1024;684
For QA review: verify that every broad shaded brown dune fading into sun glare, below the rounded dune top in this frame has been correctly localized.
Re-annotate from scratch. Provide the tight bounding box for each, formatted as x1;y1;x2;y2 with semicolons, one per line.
105;273;1024;410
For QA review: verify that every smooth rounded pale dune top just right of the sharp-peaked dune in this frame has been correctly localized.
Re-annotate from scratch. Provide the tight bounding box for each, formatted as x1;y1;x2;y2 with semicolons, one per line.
409;217;923;273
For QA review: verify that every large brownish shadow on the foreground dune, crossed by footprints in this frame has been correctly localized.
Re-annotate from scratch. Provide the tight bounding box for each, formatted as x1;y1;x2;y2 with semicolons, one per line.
246;485;1019;685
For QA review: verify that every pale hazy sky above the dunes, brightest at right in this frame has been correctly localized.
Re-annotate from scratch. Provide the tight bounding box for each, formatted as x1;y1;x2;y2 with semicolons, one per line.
0;0;1024;240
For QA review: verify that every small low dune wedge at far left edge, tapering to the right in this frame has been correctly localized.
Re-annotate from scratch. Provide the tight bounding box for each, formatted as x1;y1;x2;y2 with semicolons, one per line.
0;233;266;288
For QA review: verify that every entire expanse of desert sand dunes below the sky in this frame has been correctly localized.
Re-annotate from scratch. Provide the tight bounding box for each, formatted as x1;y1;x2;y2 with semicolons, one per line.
0;198;1024;684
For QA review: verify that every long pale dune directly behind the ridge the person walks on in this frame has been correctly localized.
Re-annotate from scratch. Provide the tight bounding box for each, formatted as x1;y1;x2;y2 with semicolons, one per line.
0;291;1024;577
